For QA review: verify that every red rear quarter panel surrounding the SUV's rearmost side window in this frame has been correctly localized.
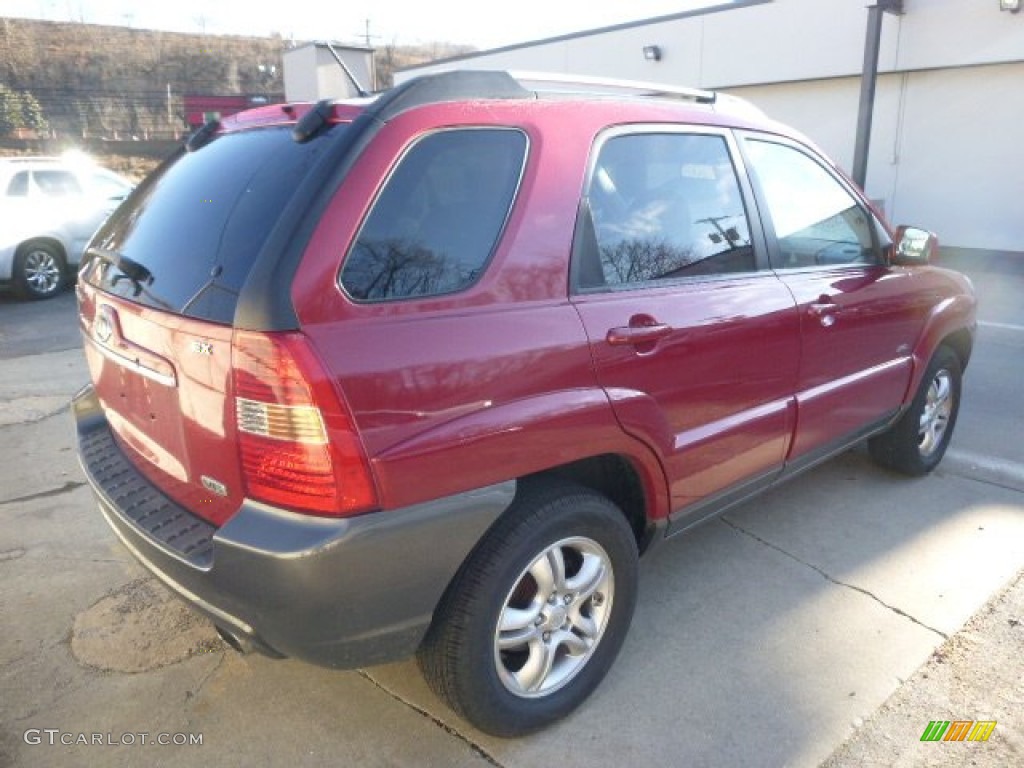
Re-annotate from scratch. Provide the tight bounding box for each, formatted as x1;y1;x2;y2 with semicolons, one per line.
293;104;670;517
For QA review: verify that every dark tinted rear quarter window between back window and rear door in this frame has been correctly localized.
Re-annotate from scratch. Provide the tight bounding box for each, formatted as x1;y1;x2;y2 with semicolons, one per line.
341;128;526;301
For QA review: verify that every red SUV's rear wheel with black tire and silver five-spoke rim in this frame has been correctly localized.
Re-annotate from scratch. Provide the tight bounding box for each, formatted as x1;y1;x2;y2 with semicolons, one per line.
418;482;638;737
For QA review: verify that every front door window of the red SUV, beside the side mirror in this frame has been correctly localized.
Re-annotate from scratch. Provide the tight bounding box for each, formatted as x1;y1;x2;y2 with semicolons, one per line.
746;140;877;268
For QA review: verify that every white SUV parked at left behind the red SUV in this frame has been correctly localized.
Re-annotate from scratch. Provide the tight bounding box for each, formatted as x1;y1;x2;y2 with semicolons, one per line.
0;158;132;299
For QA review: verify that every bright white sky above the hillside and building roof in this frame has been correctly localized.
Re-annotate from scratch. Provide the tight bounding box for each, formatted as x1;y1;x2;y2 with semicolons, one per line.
0;0;729;48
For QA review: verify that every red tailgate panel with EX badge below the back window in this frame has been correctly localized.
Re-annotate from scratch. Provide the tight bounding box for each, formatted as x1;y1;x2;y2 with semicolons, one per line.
78;283;245;525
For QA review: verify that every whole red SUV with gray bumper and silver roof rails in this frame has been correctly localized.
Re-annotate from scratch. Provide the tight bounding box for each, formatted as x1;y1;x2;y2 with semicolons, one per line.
74;72;975;735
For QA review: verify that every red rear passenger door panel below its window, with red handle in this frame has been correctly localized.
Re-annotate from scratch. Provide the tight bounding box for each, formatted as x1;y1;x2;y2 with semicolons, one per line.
575;272;800;509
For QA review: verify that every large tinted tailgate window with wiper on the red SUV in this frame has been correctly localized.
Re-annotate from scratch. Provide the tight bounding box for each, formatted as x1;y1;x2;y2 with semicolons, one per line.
81;126;344;324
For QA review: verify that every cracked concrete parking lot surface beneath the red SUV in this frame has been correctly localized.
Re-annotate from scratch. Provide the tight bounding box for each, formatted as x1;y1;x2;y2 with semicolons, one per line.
0;264;1024;767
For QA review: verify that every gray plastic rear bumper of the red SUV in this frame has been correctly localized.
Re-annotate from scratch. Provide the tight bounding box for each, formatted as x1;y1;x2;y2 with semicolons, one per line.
72;387;515;669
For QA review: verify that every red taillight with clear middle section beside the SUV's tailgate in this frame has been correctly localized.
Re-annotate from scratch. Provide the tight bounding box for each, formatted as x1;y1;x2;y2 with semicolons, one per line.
231;331;377;515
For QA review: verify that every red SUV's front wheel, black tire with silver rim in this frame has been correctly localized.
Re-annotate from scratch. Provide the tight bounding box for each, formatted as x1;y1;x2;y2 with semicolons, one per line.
867;346;963;476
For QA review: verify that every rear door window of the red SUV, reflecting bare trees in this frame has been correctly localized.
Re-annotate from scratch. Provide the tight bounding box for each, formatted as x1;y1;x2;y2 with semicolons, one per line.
577;133;755;290
